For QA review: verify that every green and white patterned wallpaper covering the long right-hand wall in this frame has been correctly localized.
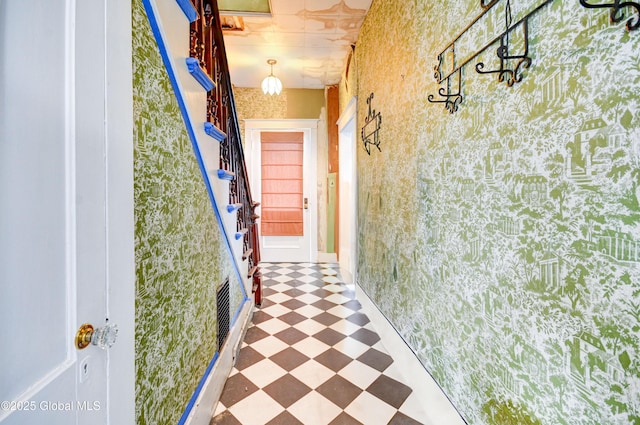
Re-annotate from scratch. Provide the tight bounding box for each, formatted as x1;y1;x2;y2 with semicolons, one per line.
350;0;640;425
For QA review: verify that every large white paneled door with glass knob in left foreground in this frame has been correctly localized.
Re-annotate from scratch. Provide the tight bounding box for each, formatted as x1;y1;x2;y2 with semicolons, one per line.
0;0;135;425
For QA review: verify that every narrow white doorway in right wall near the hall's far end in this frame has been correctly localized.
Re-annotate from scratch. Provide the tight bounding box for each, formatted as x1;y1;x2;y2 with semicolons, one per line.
337;97;358;283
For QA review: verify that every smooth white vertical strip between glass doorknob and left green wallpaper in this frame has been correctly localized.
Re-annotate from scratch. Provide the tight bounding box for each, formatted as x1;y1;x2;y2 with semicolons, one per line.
105;0;136;425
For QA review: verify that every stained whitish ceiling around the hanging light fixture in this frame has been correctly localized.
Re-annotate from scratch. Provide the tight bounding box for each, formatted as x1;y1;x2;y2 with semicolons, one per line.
224;0;372;89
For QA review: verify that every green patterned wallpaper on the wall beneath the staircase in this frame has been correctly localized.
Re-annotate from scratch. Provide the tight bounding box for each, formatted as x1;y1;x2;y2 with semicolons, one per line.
133;0;243;425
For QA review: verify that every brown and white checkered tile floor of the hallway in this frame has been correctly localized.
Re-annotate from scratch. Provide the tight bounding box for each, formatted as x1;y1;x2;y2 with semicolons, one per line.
211;263;426;425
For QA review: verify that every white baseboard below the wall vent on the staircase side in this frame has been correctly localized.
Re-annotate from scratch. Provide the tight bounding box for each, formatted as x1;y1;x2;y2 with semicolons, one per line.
185;298;253;425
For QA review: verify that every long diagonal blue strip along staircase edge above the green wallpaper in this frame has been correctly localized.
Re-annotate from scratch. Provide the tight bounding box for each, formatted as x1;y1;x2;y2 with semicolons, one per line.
142;0;249;299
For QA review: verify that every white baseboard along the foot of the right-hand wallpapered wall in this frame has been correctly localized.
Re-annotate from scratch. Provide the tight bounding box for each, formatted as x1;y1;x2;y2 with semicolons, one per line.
356;285;466;425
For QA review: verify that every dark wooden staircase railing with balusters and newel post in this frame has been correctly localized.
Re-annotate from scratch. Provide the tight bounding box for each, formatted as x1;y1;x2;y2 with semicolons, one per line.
189;0;262;305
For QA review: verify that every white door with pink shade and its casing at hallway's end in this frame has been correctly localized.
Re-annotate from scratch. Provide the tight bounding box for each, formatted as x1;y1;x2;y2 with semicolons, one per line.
245;119;318;263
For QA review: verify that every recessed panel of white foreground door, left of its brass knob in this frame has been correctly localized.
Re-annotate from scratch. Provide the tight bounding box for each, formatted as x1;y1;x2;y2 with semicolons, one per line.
0;0;76;423
